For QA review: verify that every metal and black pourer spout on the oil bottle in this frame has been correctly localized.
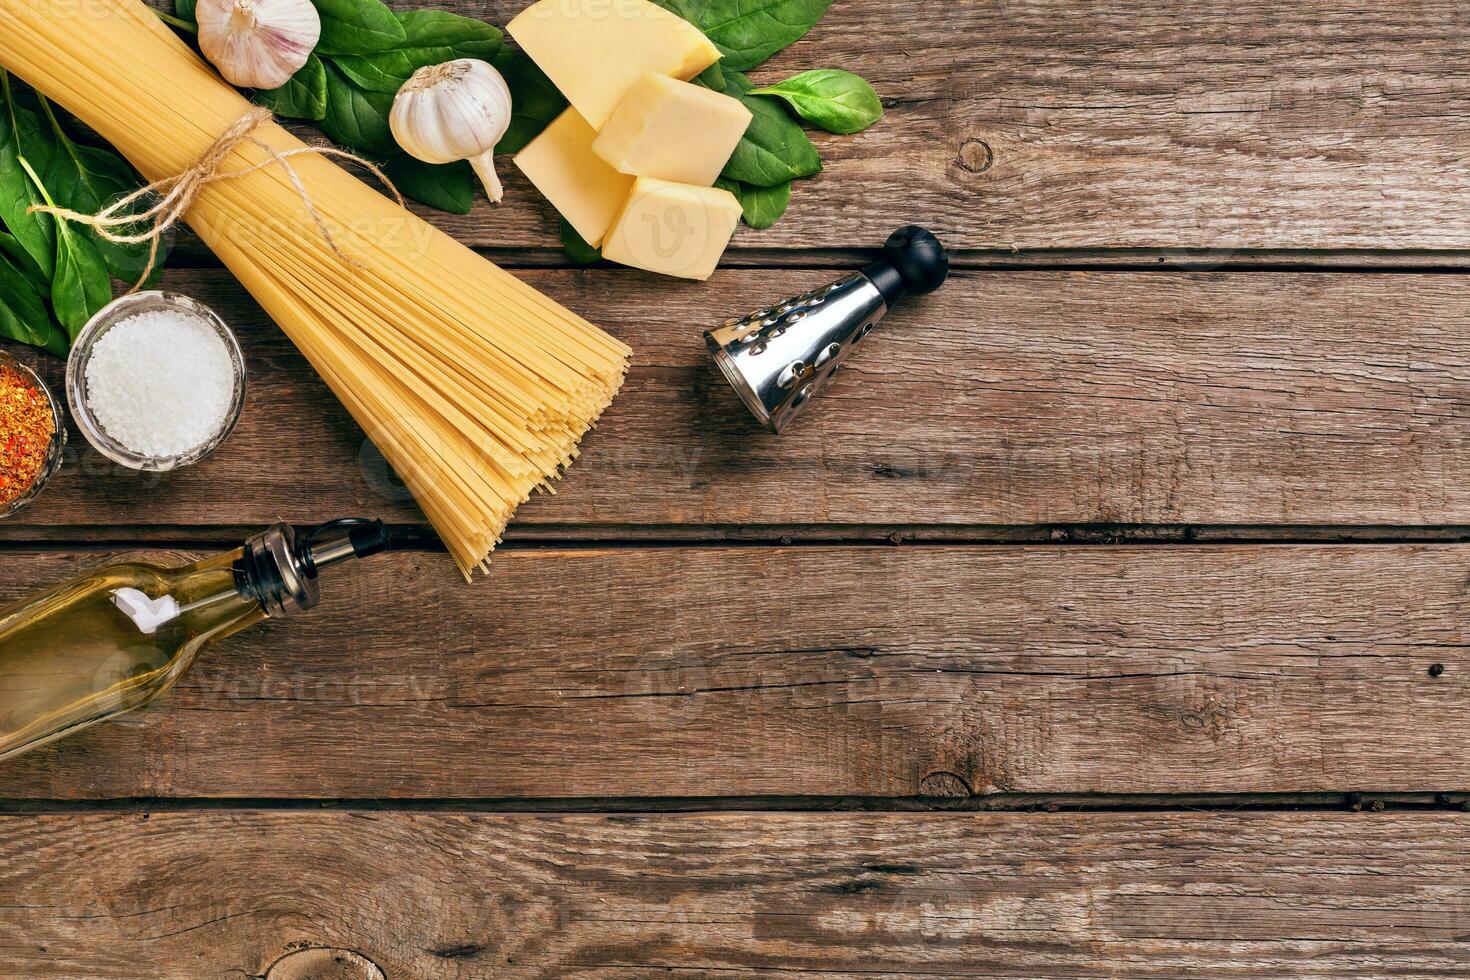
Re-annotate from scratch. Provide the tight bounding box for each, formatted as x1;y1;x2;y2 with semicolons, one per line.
235;517;390;619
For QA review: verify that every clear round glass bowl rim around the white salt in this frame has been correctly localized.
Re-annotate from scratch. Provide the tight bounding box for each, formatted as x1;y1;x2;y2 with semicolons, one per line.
66;289;245;473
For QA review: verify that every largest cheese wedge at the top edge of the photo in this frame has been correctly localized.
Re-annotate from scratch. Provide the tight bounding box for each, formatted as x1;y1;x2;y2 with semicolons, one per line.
506;0;720;129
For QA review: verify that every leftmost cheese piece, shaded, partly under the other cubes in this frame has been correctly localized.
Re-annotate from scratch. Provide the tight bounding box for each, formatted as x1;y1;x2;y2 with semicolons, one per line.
516;109;634;247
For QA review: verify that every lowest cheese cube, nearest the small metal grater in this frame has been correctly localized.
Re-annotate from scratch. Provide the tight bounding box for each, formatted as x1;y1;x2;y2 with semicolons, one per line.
603;176;739;279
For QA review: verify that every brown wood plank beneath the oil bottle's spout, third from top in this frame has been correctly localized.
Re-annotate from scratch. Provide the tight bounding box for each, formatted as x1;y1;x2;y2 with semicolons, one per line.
0;545;1470;799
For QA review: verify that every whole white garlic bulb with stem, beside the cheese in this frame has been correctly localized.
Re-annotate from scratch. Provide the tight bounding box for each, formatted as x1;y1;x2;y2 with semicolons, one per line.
388;57;510;201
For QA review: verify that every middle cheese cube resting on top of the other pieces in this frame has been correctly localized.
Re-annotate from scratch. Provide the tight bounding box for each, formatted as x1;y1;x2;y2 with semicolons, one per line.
592;72;751;187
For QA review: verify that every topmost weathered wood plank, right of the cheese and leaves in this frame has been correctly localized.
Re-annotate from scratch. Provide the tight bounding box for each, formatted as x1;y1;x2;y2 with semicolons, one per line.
143;0;1470;254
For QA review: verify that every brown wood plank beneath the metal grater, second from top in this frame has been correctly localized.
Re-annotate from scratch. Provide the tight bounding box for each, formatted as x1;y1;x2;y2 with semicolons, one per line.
14;264;1470;538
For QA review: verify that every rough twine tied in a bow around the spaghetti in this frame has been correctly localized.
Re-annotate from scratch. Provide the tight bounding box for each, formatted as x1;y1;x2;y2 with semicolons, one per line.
29;106;407;292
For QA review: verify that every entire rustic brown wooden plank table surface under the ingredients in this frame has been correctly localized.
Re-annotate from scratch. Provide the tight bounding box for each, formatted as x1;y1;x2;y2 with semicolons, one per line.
0;0;1470;980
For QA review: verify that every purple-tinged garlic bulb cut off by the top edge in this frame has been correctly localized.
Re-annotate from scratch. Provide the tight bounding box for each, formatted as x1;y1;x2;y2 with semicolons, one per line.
194;0;322;88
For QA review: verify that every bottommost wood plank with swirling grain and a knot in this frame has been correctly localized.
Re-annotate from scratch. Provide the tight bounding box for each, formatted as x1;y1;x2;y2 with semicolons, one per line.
0;811;1470;980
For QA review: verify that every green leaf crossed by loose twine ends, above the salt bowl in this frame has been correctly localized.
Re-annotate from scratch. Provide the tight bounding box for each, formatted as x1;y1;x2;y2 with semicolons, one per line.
41;101;168;285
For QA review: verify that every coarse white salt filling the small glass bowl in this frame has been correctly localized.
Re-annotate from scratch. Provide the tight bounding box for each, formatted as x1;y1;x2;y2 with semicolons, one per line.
87;310;235;458
